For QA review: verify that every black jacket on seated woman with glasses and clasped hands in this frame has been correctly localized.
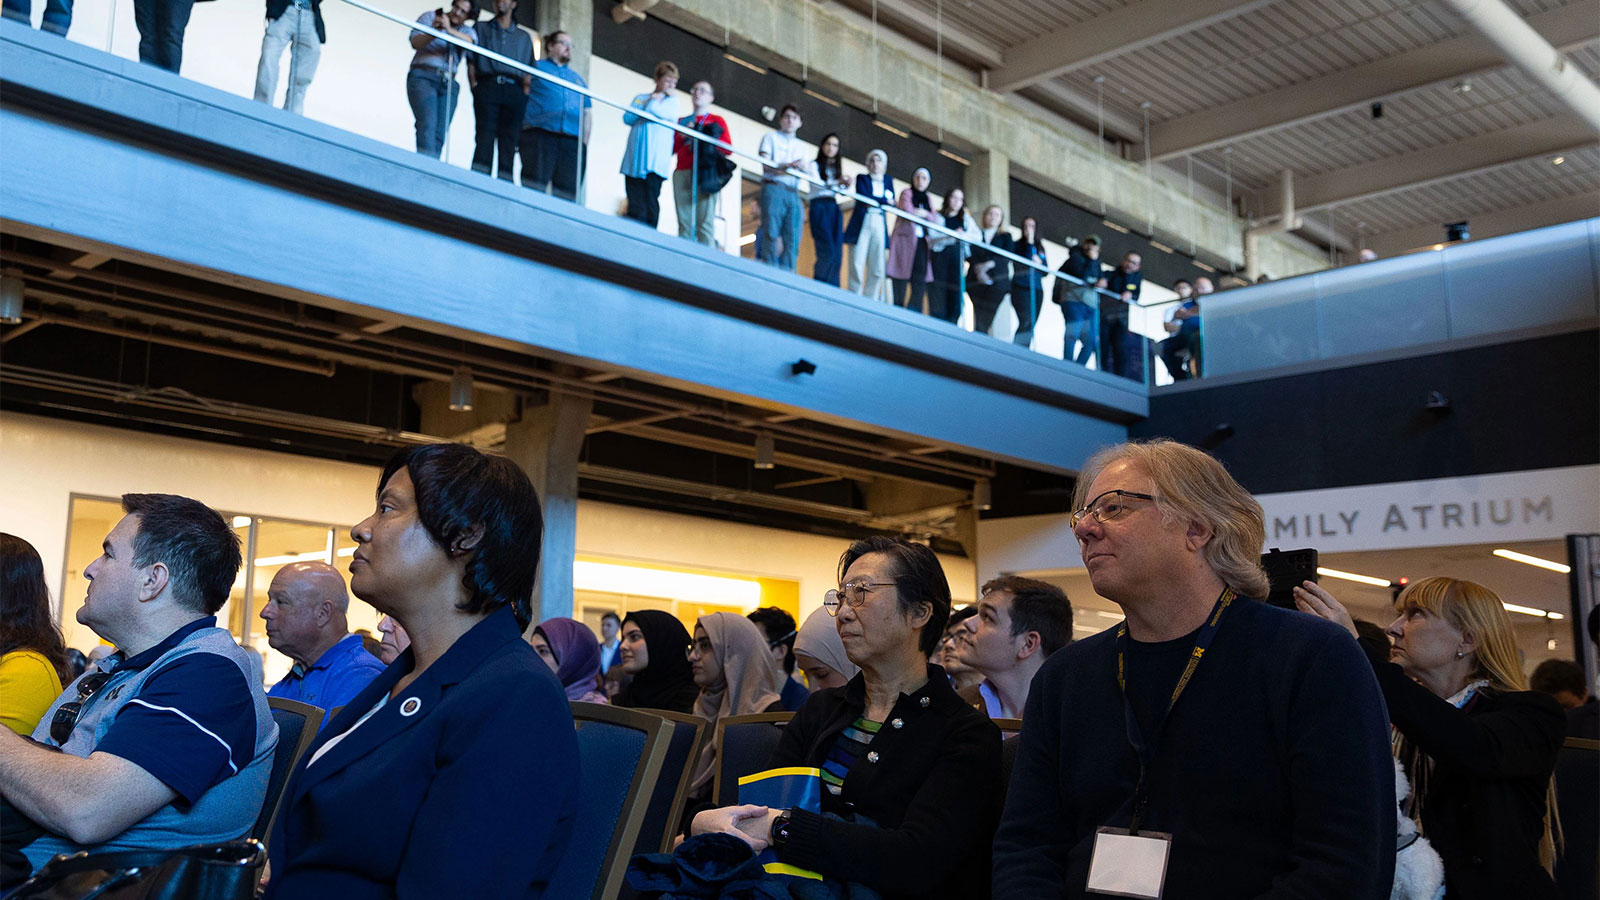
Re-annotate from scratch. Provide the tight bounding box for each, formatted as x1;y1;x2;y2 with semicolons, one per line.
773;666;1002;900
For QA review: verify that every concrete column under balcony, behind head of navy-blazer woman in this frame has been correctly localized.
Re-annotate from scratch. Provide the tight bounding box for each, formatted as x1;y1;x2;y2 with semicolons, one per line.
506;394;594;623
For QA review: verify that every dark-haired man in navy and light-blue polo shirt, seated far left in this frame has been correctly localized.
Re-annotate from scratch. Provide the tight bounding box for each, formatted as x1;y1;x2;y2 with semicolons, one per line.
0;493;278;870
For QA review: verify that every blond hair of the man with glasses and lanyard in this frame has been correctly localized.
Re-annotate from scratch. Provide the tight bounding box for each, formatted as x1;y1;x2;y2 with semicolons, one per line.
1072;439;1267;599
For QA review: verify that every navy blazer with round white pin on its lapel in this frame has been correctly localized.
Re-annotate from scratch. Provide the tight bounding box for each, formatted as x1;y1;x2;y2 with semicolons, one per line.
267;609;578;900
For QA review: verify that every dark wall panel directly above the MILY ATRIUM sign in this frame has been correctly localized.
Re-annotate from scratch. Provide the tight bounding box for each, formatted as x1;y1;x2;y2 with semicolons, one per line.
1130;330;1600;493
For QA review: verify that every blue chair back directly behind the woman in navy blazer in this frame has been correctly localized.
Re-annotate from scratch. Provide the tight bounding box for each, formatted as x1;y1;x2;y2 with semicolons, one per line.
546;703;672;900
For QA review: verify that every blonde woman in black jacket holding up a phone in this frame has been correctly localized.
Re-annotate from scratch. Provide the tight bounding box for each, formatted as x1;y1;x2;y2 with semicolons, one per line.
1294;577;1561;900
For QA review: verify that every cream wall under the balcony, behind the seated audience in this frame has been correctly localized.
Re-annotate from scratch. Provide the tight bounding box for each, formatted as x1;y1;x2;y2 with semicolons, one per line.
0;413;976;627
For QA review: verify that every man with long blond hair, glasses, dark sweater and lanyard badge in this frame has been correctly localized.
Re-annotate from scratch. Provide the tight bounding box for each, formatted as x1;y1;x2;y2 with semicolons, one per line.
994;440;1395;900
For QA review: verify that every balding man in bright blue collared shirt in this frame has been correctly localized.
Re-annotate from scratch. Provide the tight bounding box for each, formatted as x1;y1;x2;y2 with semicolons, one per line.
261;562;384;724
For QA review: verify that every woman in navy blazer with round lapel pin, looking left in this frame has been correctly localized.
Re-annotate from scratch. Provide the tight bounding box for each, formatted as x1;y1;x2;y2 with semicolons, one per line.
267;444;578;900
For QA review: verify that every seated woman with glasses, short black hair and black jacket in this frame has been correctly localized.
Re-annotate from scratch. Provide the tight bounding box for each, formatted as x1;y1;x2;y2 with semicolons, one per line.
690;536;1002;900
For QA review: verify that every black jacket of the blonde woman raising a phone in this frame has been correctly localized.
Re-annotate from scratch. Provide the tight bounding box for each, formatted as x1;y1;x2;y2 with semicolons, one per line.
1373;643;1566;900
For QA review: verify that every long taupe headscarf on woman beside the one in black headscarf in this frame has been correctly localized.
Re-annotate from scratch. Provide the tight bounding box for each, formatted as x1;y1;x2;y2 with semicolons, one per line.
690;612;784;796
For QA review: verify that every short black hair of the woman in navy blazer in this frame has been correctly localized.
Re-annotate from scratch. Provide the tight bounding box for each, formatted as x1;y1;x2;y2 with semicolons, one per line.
378;444;544;629
